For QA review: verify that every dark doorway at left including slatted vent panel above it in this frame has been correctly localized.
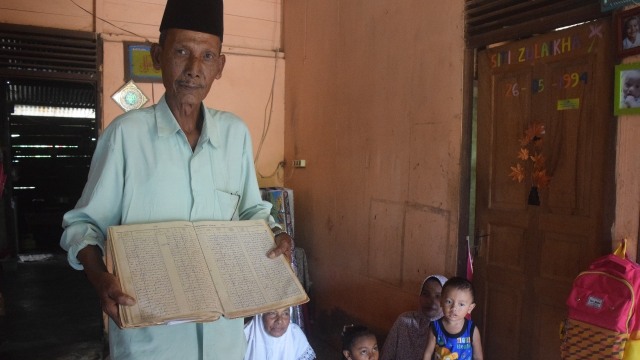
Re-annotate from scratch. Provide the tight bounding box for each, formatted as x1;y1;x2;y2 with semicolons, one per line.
0;24;101;259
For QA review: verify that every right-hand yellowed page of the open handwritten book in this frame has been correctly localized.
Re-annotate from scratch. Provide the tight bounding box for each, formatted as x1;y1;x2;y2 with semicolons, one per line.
194;220;309;318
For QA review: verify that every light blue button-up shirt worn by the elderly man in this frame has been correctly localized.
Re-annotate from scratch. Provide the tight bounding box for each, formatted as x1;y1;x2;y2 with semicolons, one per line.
60;97;275;360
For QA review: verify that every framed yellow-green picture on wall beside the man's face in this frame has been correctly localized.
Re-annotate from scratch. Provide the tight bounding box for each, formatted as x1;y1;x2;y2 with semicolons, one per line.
124;42;162;82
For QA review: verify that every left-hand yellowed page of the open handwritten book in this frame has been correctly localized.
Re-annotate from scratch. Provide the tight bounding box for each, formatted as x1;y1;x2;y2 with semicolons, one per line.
109;222;222;326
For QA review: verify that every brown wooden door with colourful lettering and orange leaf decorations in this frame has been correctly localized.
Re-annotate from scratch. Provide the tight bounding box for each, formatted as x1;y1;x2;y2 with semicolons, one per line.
474;20;615;360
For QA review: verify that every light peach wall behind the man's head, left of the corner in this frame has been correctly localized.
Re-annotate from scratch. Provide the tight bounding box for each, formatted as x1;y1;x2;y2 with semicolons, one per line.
0;0;285;186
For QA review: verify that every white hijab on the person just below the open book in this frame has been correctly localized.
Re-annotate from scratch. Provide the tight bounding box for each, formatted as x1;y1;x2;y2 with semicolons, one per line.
244;314;316;360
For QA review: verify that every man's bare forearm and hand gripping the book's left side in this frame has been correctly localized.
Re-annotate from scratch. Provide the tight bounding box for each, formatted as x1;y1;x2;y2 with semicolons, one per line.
78;246;136;327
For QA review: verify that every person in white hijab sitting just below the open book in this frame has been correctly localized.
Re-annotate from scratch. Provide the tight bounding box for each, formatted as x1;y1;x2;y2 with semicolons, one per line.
244;308;316;360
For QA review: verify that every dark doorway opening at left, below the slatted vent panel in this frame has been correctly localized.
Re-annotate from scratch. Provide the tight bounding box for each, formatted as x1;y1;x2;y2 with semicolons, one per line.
1;78;98;255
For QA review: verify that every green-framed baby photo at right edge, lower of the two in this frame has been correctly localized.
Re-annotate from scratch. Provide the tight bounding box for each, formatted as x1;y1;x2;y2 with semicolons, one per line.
613;63;640;115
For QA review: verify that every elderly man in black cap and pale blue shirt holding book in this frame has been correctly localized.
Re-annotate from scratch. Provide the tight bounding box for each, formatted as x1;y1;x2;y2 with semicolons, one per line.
60;0;293;360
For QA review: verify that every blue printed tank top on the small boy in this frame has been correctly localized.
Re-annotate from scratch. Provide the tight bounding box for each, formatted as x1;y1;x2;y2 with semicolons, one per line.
431;319;475;360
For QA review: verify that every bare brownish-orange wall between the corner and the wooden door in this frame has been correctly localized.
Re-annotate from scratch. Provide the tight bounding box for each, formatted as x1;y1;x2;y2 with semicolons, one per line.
284;0;468;335
